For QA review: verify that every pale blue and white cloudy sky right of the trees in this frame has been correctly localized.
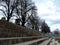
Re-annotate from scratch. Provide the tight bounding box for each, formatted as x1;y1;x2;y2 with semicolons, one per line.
33;0;60;31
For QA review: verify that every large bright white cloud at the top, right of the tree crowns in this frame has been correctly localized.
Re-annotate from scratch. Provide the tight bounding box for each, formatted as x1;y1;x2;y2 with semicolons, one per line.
37;1;56;15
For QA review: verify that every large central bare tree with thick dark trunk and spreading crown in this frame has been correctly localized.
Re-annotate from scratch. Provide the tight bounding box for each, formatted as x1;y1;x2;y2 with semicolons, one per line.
14;0;35;26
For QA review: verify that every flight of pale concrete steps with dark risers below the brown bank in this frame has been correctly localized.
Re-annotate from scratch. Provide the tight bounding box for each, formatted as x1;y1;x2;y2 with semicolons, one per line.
0;36;52;45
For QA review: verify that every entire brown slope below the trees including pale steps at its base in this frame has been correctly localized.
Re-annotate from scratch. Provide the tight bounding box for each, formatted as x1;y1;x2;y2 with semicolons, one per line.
0;20;52;45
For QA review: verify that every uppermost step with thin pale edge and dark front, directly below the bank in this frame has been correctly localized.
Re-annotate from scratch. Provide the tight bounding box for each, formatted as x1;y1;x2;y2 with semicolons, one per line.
0;36;46;45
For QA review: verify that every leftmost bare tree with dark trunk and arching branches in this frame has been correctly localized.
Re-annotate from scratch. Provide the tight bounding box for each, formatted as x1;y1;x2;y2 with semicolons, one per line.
0;0;18;21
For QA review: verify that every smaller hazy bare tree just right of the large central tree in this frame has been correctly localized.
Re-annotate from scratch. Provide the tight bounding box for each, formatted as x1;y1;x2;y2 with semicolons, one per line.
25;7;40;30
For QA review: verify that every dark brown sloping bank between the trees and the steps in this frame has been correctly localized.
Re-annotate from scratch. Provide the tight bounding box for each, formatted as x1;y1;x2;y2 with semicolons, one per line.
0;20;41;37
